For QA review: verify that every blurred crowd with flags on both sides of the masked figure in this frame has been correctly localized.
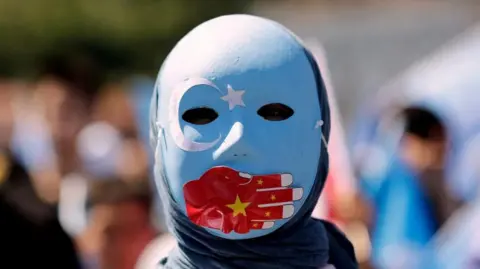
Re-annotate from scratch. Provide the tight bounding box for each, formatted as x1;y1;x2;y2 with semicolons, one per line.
0;7;480;269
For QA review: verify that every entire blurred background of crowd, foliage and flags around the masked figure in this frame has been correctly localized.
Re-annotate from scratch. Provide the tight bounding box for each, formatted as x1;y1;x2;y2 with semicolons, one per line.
0;0;480;269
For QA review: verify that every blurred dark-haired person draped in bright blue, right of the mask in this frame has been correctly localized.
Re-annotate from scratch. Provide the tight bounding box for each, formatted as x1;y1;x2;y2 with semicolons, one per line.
372;107;454;268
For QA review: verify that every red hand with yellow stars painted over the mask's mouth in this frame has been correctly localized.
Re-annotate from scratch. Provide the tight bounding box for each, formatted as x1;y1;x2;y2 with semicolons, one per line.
183;167;303;234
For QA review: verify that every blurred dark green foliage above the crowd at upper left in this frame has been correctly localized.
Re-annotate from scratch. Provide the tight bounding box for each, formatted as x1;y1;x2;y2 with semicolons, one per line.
0;0;250;76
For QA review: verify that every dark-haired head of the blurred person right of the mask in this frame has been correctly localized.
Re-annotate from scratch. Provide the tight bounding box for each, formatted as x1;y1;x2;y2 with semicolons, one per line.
402;108;448;172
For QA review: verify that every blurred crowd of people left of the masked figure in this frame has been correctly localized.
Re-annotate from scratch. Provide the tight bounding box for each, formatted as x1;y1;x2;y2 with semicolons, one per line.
0;51;163;269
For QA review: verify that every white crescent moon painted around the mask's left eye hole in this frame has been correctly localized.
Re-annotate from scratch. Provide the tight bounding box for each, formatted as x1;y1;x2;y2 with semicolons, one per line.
168;78;221;151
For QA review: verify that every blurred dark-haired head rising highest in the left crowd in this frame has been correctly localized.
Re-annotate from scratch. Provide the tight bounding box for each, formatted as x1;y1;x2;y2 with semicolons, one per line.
33;53;101;172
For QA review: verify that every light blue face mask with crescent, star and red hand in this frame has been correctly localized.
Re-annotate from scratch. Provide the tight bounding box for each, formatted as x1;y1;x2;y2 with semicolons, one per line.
153;15;326;239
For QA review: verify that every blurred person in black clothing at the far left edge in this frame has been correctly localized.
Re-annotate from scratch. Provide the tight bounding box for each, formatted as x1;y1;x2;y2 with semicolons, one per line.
0;77;81;268
